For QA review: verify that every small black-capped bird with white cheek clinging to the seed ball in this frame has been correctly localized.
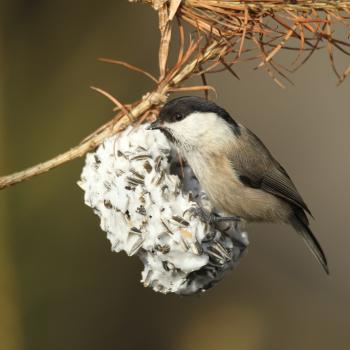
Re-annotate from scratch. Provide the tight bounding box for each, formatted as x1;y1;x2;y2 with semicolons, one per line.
149;96;329;274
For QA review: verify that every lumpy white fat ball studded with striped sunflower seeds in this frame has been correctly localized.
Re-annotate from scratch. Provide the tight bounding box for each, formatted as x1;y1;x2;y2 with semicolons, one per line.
78;125;248;294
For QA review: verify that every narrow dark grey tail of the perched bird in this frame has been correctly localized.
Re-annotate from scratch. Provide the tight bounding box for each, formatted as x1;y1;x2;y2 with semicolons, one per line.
290;208;329;275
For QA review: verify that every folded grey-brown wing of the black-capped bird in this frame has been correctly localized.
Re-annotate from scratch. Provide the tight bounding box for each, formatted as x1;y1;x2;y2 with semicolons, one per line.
231;129;311;215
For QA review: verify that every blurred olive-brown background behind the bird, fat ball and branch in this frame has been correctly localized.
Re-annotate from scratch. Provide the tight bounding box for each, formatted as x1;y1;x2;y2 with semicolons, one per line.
0;0;350;350
